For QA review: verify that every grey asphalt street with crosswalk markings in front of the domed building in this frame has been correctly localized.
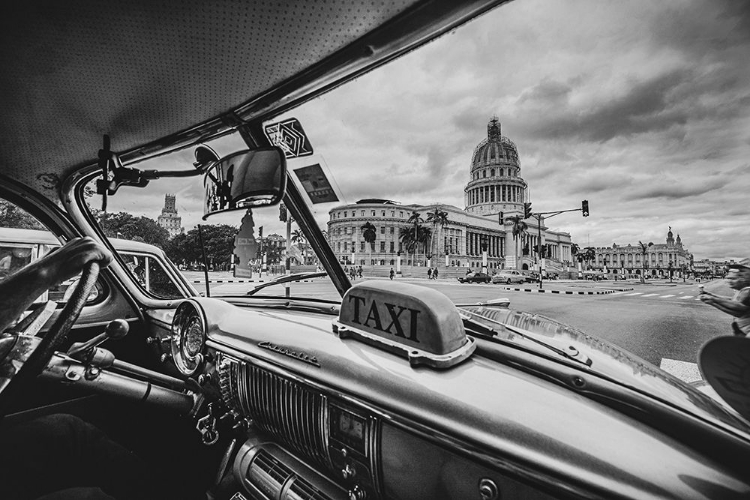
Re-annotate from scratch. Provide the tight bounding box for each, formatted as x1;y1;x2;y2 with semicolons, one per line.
185;272;732;381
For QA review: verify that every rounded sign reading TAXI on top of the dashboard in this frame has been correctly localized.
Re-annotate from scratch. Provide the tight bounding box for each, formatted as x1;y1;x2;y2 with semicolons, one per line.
333;281;476;368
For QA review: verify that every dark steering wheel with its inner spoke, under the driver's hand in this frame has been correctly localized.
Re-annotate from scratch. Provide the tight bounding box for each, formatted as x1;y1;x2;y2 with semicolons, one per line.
0;262;99;416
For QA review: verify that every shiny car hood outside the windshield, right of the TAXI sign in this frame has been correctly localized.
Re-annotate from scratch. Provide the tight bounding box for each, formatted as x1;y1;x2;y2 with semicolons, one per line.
463;306;750;434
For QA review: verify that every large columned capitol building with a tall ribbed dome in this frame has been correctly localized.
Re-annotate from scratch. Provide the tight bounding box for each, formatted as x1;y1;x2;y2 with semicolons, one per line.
328;118;574;274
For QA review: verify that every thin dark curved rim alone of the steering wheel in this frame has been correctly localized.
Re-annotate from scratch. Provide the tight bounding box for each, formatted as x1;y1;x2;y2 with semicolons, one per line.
0;262;99;416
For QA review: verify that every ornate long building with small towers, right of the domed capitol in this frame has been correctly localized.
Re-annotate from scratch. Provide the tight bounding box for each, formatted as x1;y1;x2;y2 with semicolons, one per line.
587;226;695;278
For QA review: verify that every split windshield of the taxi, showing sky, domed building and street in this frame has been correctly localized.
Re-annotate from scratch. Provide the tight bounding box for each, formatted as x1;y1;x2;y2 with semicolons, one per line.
79;1;750;422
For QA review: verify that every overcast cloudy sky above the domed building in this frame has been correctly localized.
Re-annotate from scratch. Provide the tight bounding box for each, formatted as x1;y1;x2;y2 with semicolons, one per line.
125;0;750;260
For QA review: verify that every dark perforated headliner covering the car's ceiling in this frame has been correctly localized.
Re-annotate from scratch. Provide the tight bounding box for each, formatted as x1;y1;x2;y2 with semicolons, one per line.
0;0;503;201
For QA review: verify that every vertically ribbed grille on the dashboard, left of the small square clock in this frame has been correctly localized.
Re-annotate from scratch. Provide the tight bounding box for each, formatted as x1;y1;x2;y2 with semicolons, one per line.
219;357;327;468
